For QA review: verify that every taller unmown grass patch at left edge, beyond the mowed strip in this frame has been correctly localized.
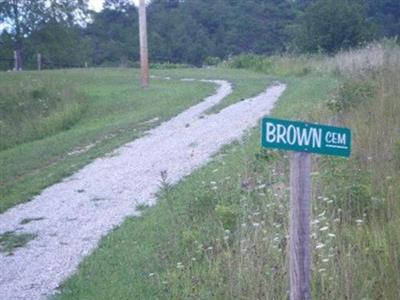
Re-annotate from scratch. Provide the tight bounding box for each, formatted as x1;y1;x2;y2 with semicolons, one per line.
0;76;87;151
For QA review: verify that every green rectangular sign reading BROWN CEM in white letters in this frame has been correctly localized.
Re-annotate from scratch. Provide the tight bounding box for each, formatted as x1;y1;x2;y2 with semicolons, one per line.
261;118;351;157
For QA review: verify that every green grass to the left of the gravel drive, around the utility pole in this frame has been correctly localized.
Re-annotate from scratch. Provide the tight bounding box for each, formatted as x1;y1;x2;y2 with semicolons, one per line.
0;69;271;212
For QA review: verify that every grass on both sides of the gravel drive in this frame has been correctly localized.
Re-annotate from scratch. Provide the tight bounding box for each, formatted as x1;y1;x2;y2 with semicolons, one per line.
0;44;400;300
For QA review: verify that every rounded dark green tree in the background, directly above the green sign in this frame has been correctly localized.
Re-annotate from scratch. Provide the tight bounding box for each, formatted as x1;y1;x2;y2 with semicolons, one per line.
296;0;373;53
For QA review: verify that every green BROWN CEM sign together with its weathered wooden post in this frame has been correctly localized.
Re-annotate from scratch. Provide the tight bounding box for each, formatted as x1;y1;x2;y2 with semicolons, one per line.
261;118;351;300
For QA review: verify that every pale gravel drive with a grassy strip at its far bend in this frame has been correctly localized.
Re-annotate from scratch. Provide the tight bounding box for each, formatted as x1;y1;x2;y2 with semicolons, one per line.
0;80;285;300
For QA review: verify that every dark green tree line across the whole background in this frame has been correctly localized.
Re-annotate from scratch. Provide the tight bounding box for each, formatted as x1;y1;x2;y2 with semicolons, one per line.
0;0;400;69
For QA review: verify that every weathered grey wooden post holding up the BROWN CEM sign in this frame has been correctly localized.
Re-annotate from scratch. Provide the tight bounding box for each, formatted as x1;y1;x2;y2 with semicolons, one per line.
289;152;312;300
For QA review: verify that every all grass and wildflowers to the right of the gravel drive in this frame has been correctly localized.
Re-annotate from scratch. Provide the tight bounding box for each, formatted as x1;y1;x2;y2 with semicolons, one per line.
55;42;400;300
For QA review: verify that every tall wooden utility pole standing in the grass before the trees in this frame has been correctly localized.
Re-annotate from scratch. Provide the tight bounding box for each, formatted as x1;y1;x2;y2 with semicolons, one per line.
139;0;149;88
